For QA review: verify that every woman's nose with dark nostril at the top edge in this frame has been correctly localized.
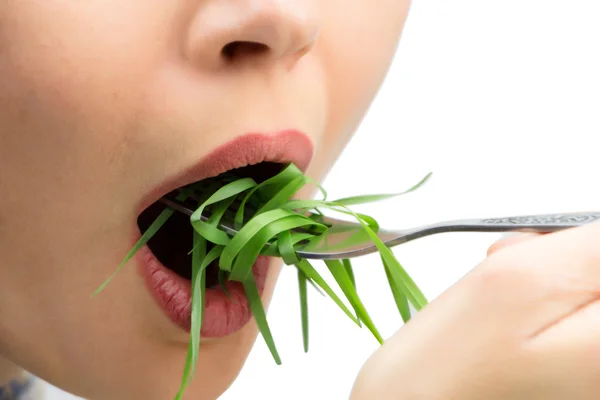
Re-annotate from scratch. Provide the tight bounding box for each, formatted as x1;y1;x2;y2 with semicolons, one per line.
184;0;321;67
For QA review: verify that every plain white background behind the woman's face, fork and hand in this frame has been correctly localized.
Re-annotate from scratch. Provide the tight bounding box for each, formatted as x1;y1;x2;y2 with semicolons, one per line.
48;0;600;400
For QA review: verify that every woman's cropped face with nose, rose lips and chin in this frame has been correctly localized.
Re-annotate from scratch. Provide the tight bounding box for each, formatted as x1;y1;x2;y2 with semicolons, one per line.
0;0;409;400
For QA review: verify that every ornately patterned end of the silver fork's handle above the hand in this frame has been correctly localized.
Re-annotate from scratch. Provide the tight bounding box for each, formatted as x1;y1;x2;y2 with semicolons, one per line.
432;211;600;233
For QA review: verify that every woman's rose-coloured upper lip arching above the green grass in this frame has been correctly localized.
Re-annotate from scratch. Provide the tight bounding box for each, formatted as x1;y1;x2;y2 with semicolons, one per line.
140;130;314;212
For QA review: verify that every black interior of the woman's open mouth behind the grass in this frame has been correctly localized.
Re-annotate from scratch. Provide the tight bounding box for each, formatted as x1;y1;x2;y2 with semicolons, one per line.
137;162;284;288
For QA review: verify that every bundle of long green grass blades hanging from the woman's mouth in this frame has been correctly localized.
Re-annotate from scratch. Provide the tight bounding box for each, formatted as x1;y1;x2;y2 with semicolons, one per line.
93;164;431;400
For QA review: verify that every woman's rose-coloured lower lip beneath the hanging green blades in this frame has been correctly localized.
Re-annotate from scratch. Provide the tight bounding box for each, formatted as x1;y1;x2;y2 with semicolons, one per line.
137;246;269;338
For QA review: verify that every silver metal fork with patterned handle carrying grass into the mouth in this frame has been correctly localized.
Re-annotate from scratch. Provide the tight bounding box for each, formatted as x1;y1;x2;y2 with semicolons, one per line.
161;197;600;260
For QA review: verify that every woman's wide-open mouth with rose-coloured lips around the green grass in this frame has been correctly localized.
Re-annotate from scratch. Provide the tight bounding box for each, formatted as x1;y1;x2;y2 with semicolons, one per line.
132;130;313;338
